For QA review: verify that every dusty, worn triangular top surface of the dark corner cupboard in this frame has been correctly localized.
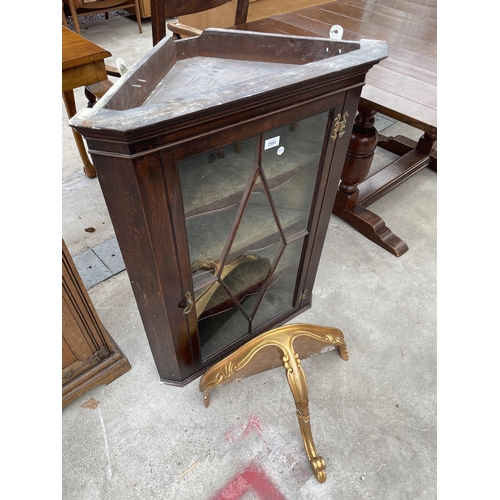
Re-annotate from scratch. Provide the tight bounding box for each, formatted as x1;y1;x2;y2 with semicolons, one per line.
70;28;387;135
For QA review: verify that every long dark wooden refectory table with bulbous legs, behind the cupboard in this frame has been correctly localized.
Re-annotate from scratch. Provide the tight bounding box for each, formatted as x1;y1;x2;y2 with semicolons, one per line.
236;0;437;257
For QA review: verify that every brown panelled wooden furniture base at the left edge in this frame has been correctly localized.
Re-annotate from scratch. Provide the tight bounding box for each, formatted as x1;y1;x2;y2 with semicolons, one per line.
62;240;130;408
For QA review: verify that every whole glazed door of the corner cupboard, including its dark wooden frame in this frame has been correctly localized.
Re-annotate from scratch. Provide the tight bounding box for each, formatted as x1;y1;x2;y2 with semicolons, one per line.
166;92;348;371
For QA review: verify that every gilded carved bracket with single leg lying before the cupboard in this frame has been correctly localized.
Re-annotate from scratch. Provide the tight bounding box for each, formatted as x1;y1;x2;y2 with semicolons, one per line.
200;323;349;483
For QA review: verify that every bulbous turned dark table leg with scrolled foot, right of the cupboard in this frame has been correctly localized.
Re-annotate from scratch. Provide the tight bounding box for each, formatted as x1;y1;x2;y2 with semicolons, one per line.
333;106;408;257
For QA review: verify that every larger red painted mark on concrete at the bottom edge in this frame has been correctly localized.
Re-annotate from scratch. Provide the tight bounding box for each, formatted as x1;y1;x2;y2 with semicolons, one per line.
211;464;286;500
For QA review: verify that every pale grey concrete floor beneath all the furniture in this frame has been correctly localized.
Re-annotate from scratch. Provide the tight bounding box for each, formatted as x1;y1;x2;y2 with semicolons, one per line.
62;12;437;500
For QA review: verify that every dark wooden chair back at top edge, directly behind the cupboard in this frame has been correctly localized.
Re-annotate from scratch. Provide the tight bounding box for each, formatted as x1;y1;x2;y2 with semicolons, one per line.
151;0;249;45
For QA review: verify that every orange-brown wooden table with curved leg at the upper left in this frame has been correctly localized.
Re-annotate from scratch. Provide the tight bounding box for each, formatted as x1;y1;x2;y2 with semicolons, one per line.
62;26;111;177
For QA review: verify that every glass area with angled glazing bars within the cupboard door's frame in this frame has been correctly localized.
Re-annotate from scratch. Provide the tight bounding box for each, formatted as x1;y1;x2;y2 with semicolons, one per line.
172;110;340;364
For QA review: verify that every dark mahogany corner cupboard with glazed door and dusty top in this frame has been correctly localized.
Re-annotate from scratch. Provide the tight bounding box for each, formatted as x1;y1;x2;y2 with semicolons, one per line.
70;29;387;385
